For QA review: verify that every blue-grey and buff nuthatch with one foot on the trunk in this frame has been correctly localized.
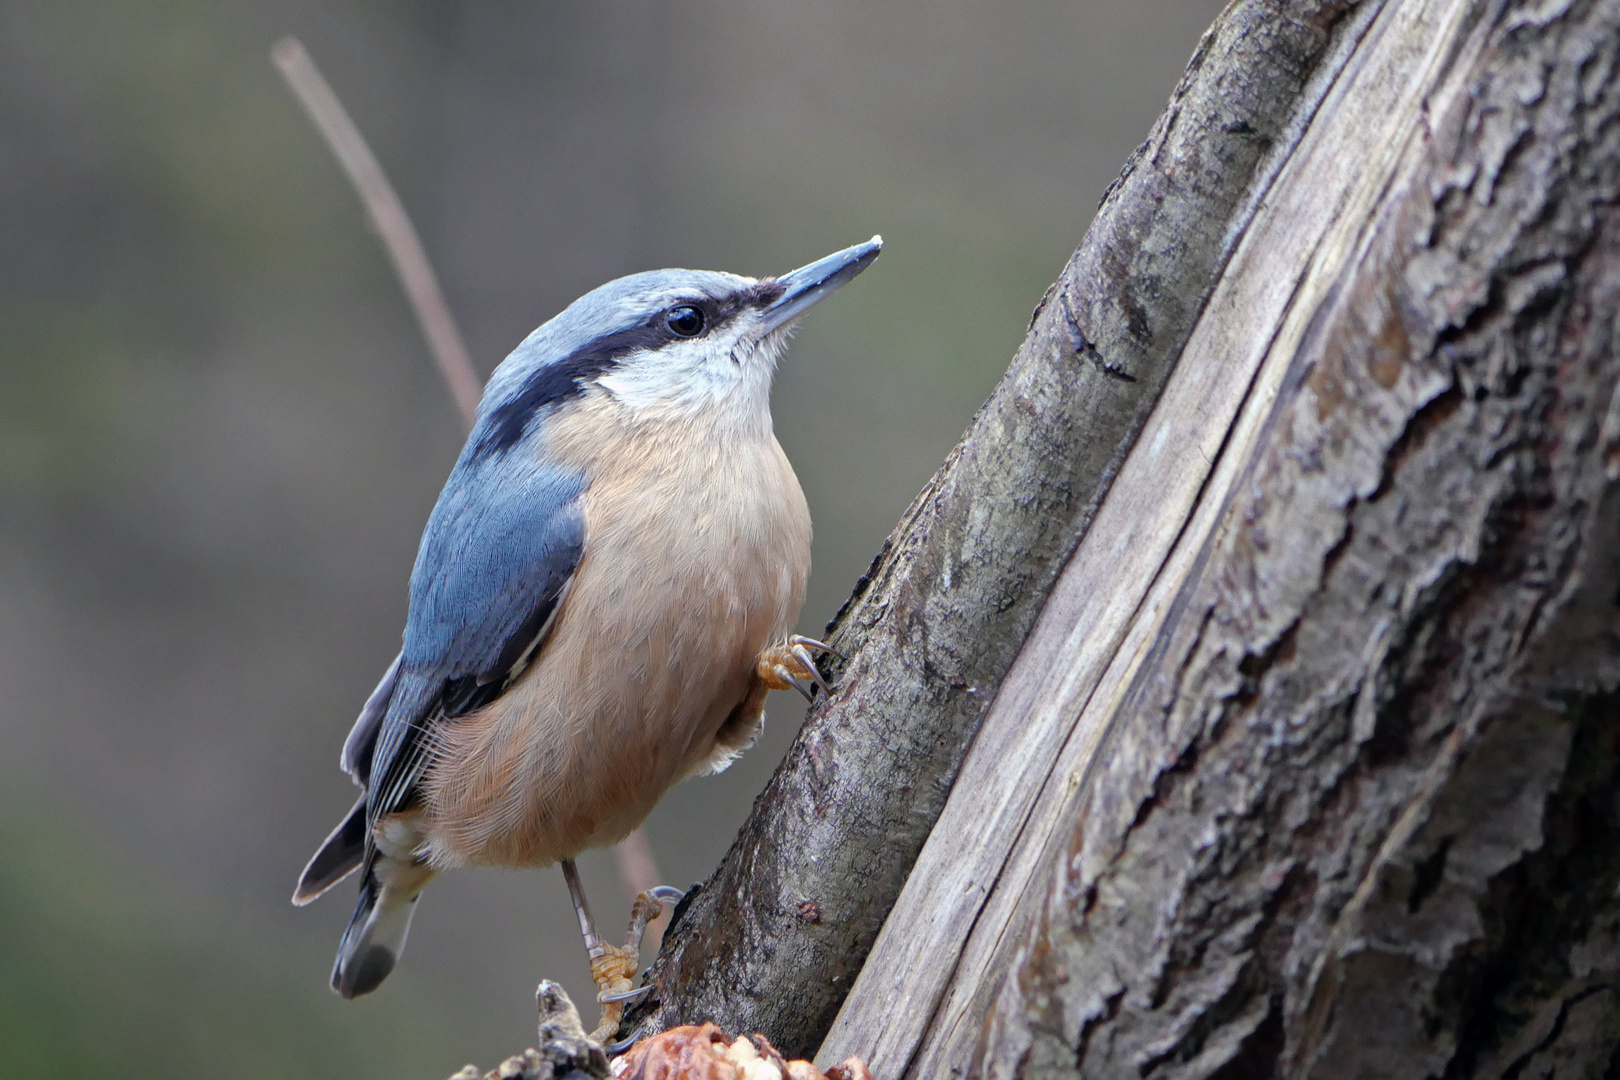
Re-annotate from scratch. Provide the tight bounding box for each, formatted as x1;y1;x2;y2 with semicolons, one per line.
293;236;883;1041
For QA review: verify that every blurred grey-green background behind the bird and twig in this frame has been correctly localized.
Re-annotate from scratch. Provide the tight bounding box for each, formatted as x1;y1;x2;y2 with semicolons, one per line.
0;0;1218;1080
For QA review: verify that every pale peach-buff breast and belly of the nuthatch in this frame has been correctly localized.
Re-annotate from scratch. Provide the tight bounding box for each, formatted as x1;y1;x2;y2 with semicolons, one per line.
411;427;810;868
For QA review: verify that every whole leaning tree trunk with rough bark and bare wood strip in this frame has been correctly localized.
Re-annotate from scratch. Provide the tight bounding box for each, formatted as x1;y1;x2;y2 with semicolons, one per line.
631;0;1620;1080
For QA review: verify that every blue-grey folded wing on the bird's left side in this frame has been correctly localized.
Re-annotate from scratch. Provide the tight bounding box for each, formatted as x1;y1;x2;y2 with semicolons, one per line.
367;455;585;821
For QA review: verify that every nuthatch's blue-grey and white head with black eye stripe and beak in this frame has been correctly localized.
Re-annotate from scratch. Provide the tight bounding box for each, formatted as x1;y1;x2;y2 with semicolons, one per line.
468;236;883;453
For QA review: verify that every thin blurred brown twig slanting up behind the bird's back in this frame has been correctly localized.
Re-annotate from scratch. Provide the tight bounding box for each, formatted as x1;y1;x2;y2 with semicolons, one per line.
271;37;483;426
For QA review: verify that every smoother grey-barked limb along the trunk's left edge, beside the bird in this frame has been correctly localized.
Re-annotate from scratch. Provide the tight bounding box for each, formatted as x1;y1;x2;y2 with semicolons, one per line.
630;0;1386;1054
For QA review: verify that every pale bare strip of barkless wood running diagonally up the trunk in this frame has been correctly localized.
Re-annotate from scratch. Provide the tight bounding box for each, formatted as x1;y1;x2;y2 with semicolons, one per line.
821;0;1490;1077
